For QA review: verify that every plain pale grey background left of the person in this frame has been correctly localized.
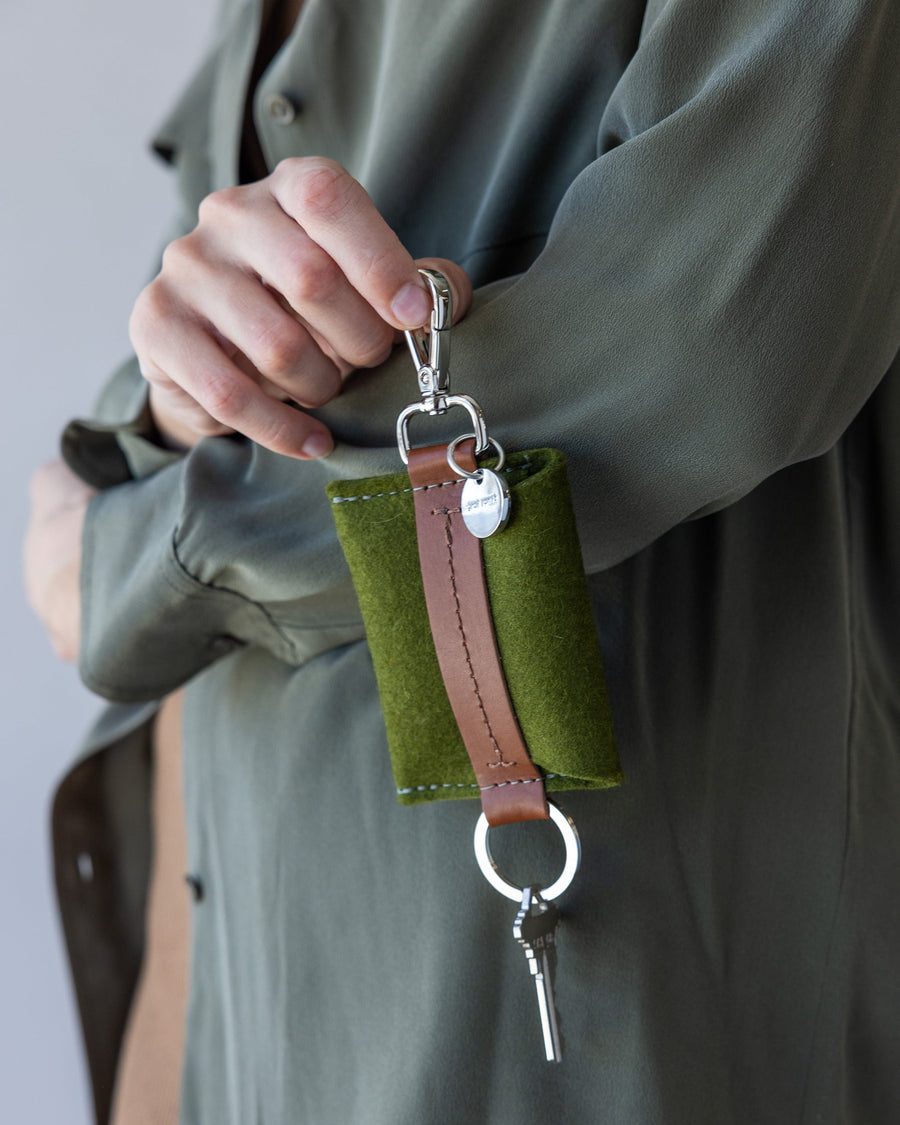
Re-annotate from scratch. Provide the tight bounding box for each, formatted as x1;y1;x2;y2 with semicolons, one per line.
0;0;213;1125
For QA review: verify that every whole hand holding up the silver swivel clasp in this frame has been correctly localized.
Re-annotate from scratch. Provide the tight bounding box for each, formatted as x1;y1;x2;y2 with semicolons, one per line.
131;158;471;458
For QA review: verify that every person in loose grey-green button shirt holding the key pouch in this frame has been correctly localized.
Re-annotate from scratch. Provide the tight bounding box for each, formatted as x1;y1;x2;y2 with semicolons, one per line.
28;0;900;1125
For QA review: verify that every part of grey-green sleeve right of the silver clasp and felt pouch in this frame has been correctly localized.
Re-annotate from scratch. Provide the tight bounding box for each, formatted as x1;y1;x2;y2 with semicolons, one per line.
429;0;900;569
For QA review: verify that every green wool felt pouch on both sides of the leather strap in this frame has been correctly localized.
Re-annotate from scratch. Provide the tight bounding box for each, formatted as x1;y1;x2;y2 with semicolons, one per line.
327;449;622;804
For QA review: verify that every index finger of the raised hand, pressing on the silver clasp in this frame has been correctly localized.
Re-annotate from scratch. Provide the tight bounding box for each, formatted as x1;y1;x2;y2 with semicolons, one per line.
269;158;431;329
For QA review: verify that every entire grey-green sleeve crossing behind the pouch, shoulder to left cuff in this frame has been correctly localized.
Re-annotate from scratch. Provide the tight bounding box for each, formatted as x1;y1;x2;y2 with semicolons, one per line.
70;0;900;698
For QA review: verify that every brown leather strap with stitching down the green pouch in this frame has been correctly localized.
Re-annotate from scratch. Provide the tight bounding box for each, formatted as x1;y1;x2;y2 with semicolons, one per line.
410;440;549;825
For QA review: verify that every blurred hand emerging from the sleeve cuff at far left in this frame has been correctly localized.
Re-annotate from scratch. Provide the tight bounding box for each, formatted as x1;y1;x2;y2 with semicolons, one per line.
24;461;96;660
